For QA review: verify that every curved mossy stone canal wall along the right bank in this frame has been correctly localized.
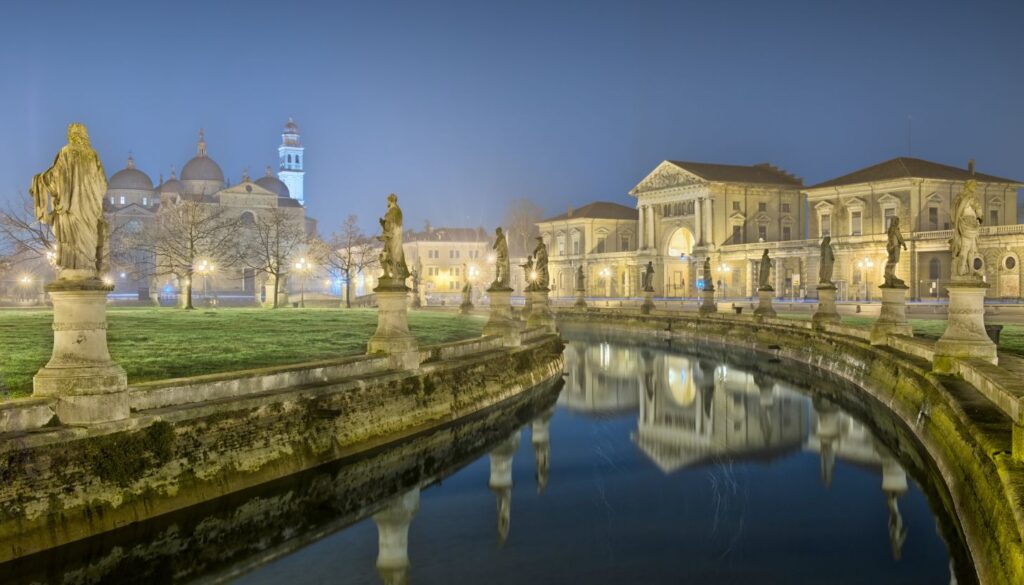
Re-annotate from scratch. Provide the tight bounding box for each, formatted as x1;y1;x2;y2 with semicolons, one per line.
556;308;1024;585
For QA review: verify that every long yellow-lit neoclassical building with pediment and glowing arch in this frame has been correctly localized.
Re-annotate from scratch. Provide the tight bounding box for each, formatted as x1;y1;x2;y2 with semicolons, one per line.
552;157;1024;300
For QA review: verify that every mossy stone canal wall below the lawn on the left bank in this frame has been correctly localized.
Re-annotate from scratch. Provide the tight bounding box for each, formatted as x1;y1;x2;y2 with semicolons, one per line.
0;330;563;562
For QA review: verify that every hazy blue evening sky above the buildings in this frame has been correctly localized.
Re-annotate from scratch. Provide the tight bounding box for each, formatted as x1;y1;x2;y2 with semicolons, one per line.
0;0;1024;234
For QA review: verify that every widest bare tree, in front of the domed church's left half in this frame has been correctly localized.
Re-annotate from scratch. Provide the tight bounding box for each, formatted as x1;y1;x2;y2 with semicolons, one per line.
135;199;241;309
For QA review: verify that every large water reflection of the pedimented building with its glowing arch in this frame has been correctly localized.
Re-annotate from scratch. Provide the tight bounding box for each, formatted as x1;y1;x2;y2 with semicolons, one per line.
633;353;807;473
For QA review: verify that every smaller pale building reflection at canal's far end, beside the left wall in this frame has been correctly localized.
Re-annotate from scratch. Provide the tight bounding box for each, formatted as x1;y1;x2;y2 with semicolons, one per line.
558;341;640;413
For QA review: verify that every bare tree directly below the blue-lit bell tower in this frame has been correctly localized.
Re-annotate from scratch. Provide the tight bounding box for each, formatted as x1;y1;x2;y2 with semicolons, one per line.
241;207;307;308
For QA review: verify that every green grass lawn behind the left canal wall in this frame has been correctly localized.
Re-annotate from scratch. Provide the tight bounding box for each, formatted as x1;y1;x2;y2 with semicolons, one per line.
0;308;485;396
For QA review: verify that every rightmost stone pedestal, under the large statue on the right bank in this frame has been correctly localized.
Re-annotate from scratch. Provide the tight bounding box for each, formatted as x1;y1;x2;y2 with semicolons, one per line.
933;282;997;373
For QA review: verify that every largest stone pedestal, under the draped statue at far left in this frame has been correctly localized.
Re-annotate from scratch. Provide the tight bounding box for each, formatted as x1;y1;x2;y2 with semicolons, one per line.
33;279;130;424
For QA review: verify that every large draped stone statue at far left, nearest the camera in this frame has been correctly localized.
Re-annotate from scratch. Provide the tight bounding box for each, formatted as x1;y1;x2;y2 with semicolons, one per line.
29;124;109;280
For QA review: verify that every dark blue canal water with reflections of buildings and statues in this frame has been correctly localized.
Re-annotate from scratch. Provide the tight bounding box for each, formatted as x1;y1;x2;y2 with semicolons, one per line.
7;331;975;585
